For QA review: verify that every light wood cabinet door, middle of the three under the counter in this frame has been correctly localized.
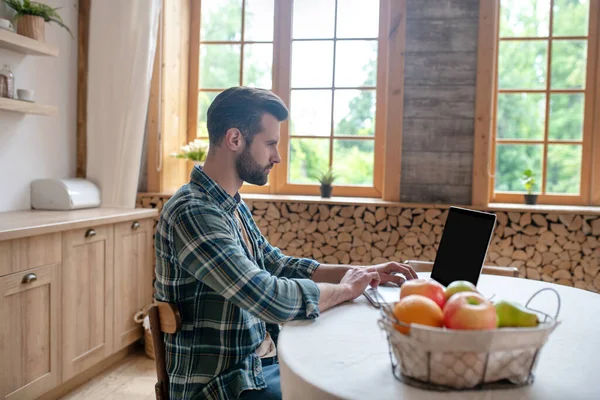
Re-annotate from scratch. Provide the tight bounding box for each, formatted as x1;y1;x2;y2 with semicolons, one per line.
62;225;114;381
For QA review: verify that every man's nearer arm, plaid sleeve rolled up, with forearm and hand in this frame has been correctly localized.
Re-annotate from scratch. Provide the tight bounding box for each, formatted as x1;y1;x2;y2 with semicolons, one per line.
173;207;378;323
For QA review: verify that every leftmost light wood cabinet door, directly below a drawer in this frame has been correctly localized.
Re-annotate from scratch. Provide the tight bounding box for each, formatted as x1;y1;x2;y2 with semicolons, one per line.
0;264;60;400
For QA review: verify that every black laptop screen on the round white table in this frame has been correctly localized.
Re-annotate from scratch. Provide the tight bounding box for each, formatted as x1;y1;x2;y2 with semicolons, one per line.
431;207;496;286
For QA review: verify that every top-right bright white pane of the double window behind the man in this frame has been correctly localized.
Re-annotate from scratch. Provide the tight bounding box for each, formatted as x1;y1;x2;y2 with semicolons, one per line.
336;0;379;38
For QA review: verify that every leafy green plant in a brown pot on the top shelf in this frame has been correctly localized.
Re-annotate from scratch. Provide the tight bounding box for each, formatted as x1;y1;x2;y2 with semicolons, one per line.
2;0;73;41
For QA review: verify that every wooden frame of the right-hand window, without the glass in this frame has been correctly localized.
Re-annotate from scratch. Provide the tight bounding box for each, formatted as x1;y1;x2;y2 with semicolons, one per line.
472;0;600;206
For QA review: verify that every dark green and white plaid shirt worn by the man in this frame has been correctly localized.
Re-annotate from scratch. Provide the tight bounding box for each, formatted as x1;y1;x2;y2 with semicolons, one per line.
155;167;320;399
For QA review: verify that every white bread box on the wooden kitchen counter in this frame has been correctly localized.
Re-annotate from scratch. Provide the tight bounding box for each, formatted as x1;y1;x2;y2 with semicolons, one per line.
31;178;101;211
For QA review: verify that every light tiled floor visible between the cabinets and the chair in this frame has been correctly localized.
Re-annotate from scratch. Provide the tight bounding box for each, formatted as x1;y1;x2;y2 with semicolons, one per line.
62;350;156;400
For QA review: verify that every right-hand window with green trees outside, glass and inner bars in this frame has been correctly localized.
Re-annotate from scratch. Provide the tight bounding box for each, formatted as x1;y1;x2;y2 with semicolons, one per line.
489;0;600;204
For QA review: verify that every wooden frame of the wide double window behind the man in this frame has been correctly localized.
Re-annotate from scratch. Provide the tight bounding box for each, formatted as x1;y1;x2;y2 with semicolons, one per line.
180;0;406;201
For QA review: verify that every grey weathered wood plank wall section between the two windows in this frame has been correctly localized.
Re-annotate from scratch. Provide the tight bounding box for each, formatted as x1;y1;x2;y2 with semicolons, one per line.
400;0;479;204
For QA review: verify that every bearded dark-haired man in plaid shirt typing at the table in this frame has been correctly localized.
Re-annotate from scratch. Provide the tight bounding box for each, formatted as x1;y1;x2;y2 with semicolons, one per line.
155;87;416;399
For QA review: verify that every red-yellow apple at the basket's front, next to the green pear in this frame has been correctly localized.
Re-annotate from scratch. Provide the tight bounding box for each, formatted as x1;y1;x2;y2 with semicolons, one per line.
444;292;498;329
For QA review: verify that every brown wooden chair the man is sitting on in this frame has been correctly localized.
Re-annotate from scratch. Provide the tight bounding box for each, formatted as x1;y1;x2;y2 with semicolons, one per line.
148;301;181;400
